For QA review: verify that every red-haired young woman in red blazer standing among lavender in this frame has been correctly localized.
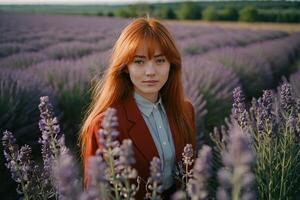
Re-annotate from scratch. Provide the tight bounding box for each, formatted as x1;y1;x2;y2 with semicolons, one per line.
80;18;196;199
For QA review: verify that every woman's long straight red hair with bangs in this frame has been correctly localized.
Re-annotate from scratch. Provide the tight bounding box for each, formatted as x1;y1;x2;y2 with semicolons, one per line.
79;18;195;170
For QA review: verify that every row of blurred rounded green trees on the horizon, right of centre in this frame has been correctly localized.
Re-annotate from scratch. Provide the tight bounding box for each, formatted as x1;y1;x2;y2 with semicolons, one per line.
101;2;300;23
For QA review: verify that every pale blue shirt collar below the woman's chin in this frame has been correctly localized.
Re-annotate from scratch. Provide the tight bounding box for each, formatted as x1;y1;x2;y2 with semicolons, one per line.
134;92;166;117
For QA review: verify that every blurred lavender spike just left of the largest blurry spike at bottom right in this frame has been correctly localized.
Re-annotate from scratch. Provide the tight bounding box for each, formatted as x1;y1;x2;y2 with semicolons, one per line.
187;145;212;200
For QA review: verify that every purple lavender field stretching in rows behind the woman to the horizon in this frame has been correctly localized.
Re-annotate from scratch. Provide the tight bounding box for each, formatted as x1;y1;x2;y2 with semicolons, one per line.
0;13;300;199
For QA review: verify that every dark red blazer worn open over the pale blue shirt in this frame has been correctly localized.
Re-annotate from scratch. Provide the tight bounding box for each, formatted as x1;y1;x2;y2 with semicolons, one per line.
84;95;196;200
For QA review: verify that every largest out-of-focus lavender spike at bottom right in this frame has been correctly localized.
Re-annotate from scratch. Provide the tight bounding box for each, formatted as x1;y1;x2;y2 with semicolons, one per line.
217;126;256;200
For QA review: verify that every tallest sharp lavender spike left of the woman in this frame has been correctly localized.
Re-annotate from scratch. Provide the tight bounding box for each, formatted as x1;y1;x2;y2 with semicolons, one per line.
39;96;67;193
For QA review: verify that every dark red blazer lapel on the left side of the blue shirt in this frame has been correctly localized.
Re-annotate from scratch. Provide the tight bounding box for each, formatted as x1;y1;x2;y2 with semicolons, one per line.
124;94;159;162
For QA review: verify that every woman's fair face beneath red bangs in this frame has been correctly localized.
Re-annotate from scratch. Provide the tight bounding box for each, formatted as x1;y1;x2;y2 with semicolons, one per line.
128;42;170;102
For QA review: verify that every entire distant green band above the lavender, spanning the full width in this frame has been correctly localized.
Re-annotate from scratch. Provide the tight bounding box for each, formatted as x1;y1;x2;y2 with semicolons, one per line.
0;0;300;23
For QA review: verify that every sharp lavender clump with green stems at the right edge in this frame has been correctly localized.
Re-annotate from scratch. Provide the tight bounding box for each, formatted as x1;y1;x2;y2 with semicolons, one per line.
211;83;300;199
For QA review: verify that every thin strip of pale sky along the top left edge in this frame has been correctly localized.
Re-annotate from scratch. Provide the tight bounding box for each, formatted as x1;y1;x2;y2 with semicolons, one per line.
0;0;188;4
